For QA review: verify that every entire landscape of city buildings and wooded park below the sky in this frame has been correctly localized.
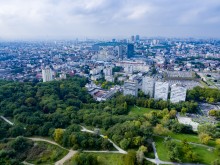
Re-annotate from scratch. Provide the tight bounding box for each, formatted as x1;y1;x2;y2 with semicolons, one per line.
0;35;220;165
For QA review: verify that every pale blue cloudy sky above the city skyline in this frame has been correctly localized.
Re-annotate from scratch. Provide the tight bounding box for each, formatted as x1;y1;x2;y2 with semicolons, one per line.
0;0;220;39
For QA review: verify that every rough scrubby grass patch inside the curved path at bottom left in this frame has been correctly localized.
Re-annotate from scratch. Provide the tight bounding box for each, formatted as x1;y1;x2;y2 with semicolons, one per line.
26;142;68;165
